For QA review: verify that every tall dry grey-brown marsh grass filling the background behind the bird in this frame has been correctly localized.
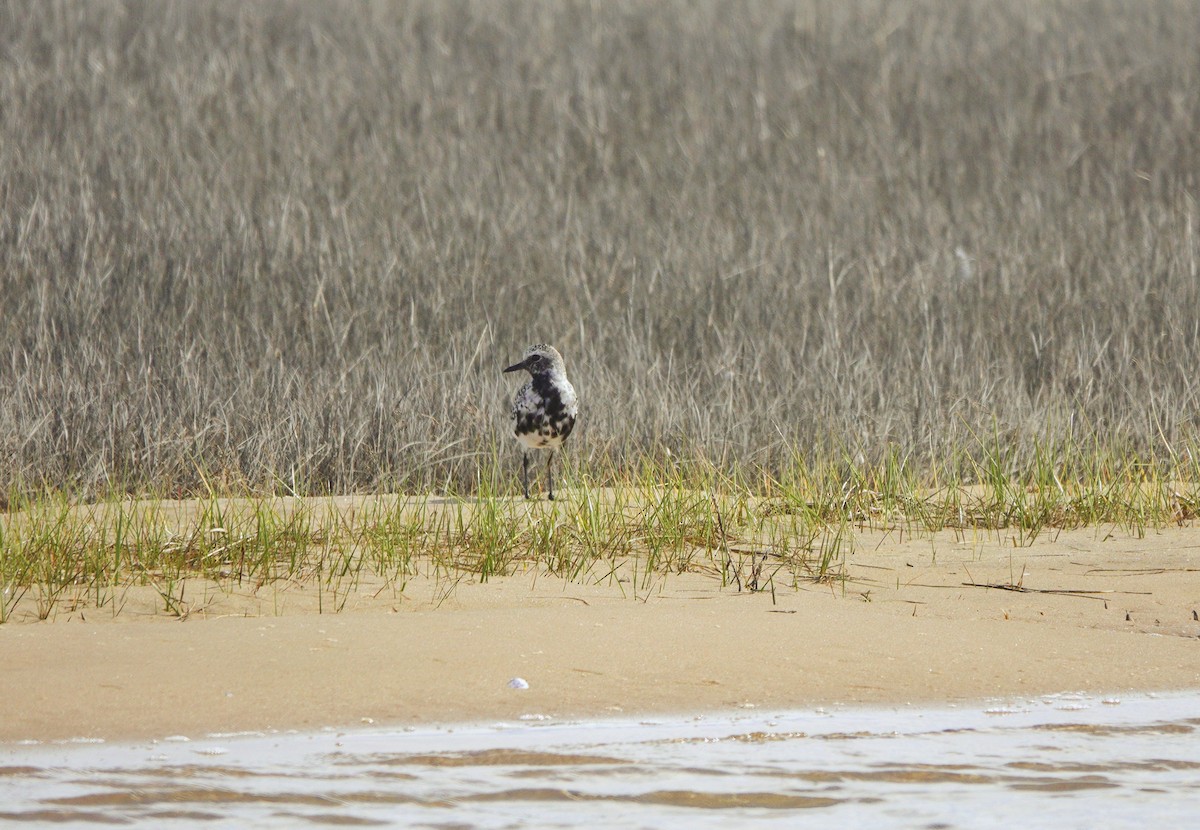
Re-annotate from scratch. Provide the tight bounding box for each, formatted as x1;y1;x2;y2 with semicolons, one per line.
0;0;1200;494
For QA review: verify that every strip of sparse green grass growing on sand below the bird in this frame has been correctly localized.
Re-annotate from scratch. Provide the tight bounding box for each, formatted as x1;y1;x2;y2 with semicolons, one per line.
0;441;1200;621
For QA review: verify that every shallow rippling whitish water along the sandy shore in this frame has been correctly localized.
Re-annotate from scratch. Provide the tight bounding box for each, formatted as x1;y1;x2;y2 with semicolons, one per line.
0;693;1200;828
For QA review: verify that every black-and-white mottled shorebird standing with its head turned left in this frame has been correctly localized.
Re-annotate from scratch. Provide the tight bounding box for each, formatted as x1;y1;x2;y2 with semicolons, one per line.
504;343;580;500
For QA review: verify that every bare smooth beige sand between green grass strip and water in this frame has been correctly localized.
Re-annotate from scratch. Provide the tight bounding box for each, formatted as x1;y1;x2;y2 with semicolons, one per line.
0;527;1200;741
